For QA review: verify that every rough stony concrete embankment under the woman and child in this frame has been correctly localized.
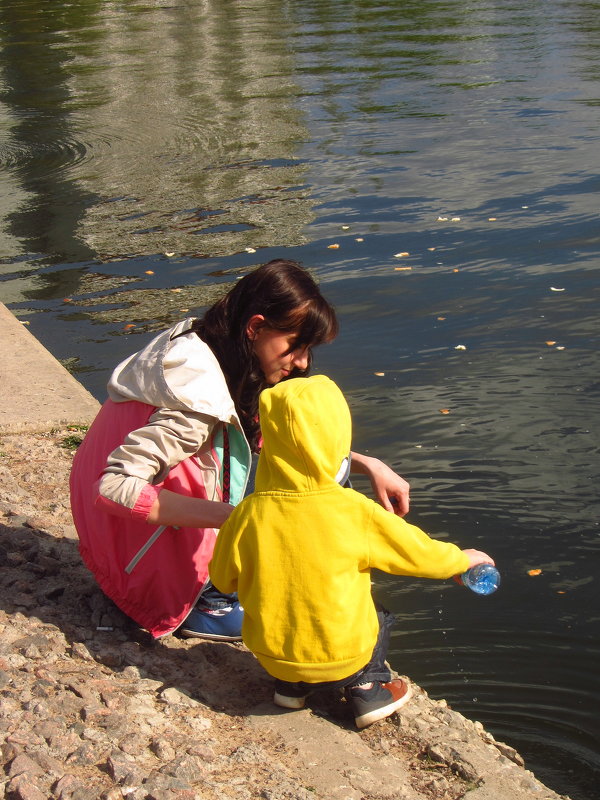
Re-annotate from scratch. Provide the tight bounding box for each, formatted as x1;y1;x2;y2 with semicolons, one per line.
0;306;559;800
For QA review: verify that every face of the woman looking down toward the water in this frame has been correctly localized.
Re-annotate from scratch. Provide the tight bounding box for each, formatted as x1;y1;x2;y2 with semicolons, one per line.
246;314;310;386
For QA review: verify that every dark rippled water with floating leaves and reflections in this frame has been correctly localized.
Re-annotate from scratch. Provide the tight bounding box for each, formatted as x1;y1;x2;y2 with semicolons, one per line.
0;0;600;800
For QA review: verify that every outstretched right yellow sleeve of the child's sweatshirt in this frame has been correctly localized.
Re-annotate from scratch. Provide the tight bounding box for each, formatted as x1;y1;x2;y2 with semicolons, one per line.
369;503;470;580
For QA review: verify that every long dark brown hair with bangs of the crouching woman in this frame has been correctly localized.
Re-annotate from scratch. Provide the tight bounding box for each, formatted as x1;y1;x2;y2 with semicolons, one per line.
193;259;338;450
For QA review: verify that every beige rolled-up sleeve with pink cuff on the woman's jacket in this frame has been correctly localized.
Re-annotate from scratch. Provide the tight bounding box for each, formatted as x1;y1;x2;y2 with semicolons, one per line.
96;408;215;519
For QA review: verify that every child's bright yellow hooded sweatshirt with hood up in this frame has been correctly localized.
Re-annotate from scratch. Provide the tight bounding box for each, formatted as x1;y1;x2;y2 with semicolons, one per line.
209;375;469;683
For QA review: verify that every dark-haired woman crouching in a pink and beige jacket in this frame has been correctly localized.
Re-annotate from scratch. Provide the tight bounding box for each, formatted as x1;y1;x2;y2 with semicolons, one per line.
71;260;408;640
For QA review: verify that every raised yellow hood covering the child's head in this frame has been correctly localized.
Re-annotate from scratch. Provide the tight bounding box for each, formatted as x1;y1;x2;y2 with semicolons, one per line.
256;375;352;492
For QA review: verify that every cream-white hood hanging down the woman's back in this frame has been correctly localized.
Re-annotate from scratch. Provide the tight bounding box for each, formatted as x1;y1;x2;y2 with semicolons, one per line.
108;317;239;424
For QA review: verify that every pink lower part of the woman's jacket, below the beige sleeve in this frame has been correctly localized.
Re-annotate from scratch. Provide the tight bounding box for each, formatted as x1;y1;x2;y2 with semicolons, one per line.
71;400;220;637
